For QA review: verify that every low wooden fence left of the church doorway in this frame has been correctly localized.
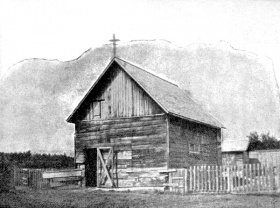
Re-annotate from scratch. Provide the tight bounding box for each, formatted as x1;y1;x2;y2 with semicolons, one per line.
14;167;82;189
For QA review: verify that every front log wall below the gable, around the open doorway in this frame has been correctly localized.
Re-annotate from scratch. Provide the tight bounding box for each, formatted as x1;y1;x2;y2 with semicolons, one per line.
75;114;167;187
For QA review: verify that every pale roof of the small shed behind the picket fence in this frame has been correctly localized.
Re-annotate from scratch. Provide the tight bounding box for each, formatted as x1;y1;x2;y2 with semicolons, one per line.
222;140;249;152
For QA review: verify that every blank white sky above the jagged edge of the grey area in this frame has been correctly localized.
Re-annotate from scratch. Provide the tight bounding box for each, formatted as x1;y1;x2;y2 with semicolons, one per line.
0;0;280;82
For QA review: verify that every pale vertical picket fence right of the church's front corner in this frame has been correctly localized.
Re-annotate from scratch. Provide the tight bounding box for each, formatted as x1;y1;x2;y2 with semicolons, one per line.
165;164;280;193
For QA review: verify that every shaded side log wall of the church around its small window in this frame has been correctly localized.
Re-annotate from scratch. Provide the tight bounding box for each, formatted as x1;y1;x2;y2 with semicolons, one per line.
169;117;221;168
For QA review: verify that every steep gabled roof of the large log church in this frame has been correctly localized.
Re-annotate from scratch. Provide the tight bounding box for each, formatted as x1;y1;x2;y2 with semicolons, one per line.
67;57;224;128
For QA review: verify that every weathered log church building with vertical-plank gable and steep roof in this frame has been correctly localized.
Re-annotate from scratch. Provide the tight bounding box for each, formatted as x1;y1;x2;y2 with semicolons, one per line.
67;36;223;187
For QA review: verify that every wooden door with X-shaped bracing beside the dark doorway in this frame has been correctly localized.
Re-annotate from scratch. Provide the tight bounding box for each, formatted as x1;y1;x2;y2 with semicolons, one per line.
97;147;115;187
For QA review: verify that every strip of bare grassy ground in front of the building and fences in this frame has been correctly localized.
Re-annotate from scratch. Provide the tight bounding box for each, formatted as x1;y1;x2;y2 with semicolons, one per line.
0;189;280;208
